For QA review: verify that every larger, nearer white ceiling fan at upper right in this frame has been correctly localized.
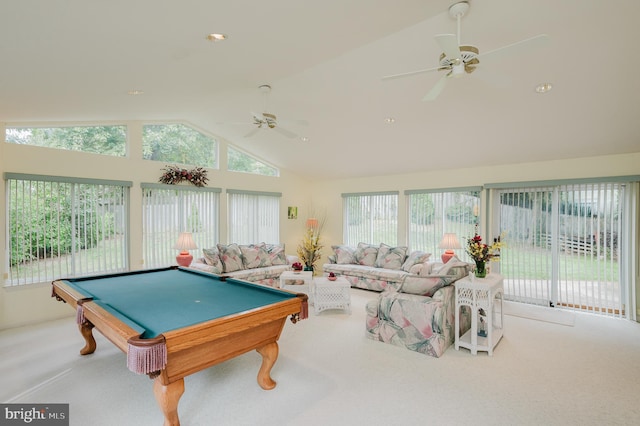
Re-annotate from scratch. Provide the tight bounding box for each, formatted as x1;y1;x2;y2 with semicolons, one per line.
382;1;549;101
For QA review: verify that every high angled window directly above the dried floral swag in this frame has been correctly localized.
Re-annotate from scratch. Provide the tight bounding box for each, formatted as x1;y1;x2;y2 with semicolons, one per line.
142;124;218;169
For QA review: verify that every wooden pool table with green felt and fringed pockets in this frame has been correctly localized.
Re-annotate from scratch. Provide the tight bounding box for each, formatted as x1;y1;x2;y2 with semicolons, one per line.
52;267;308;425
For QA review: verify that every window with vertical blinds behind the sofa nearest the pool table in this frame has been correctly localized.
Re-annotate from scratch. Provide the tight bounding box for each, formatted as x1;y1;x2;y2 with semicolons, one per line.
227;189;282;244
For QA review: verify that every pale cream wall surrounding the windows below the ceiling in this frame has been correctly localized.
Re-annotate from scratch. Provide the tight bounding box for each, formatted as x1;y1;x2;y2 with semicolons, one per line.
0;123;640;329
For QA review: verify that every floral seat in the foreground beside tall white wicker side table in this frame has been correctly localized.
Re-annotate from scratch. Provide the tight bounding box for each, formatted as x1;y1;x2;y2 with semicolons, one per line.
366;258;471;358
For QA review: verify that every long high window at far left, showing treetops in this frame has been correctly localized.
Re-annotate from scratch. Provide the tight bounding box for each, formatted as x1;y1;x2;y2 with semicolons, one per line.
5;126;127;157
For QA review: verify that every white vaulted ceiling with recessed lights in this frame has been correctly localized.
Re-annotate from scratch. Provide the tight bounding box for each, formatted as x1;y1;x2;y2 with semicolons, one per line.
0;0;640;178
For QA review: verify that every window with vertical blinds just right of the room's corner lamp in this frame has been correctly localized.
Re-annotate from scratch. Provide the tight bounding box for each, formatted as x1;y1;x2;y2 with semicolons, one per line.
342;191;398;246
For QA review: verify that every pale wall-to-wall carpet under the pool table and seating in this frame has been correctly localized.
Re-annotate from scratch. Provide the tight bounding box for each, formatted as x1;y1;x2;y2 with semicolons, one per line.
0;289;640;426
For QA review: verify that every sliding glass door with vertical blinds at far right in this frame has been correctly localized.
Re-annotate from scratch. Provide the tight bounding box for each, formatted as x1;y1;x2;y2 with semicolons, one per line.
494;183;627;316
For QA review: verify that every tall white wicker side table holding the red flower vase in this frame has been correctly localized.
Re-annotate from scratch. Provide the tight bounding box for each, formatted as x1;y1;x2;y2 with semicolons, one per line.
454;274;504;356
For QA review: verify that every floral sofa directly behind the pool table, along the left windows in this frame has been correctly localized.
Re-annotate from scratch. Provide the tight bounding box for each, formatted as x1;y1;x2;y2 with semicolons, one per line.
189;243;299;287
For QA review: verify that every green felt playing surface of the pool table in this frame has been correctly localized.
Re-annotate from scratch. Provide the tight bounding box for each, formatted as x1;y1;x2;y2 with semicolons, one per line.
62;268;295;338
